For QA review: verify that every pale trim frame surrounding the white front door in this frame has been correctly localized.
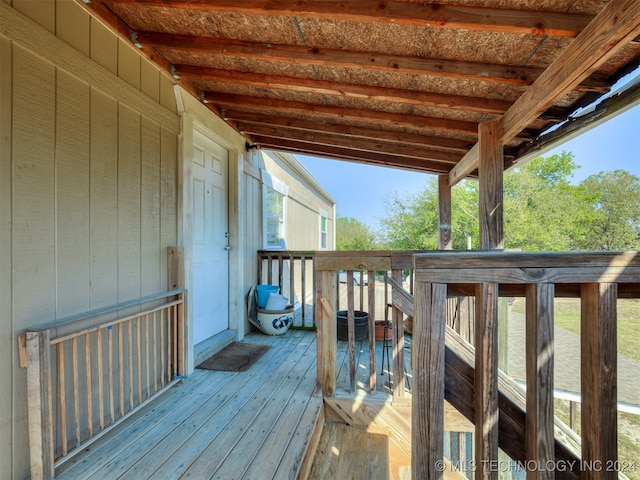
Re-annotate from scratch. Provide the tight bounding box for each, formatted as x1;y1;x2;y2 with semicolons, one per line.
177;110;246;373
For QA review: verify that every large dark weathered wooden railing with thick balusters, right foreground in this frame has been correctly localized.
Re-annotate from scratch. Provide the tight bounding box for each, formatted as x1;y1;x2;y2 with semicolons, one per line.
412;251;640;479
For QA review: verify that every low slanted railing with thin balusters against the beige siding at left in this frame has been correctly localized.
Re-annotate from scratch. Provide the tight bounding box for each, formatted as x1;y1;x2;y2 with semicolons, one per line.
19;290;186;478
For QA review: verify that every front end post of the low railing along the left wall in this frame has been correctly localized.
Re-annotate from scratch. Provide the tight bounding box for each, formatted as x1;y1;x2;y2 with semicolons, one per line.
26;330;55;480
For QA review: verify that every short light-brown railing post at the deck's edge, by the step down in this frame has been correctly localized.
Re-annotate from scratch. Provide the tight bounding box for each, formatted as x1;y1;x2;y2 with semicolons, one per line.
316;271;337;397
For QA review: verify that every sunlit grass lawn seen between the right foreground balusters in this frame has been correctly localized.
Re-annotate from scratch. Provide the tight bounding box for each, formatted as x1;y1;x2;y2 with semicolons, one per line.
513;298;640;480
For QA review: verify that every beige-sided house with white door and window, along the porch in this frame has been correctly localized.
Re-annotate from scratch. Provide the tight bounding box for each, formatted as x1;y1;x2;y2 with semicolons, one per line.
0;0;335;478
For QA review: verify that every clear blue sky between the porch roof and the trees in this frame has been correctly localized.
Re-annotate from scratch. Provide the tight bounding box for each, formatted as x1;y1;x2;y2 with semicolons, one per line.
297;105;640;230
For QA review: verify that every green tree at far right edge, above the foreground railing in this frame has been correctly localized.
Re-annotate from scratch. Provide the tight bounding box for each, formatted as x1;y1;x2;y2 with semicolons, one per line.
576;170;640;250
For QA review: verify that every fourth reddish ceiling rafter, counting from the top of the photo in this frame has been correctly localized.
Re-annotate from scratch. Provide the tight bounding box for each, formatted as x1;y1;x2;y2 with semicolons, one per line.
204;92;478;136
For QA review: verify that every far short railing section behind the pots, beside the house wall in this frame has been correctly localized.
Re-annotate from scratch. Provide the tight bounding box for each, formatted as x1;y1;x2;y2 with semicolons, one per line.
258;250;315;329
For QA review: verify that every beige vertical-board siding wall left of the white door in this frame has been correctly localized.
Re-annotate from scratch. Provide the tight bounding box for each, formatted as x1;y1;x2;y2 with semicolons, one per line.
0;0;180;478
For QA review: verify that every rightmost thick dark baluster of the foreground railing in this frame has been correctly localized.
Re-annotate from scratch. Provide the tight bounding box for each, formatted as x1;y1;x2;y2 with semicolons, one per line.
580;283;618;479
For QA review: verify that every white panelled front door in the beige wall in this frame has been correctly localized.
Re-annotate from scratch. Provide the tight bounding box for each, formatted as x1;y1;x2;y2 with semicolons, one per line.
192;131;229;344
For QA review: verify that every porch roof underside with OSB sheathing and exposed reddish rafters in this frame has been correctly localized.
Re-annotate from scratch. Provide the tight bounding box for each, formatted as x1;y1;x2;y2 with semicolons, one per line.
87;0;640;178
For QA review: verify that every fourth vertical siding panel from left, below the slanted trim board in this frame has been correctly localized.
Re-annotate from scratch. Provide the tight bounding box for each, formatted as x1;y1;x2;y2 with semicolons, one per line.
90;89;118;308
